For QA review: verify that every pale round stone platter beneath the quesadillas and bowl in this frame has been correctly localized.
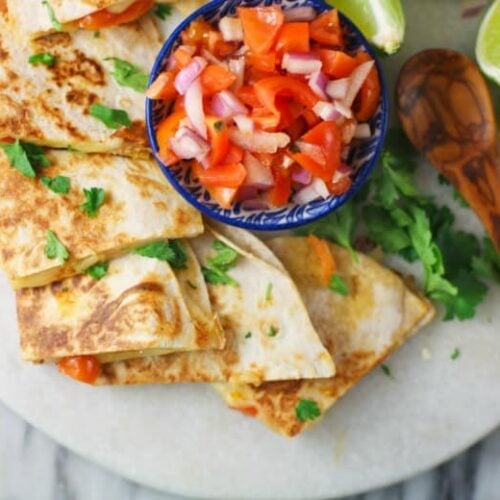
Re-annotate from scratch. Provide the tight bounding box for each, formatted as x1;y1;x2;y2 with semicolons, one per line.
0;0;500;499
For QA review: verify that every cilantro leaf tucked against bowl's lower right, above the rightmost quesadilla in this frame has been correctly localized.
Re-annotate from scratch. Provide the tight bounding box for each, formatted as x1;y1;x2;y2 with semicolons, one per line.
295;202;359;262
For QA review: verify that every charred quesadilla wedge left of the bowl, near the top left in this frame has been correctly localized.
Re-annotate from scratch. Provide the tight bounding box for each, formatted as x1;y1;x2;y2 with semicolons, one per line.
0;14;161;157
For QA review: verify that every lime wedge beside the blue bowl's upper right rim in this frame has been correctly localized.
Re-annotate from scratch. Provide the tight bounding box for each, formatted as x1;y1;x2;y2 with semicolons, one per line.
328;0;405;54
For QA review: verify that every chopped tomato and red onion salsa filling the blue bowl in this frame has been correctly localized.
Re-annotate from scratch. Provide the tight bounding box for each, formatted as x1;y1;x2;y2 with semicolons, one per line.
147;5;380;210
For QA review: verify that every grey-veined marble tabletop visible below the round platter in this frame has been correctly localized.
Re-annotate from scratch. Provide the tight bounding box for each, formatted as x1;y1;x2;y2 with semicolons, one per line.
0;403;500;500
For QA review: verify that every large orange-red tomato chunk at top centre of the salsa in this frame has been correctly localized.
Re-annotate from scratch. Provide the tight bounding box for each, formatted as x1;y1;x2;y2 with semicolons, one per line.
237;5;285;54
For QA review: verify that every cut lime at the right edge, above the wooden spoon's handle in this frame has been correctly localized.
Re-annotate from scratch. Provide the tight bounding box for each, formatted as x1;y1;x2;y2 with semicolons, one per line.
476;0;500;85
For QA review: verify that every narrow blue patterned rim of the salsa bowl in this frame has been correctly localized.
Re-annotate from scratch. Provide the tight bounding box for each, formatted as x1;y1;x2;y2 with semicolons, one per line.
146;0;389;231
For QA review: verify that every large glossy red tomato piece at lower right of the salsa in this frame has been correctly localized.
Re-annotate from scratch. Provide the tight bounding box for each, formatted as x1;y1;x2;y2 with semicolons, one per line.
289;121;342;182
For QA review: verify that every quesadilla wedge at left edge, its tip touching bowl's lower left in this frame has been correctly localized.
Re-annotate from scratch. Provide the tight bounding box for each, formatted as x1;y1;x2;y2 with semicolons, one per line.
0;150;203;288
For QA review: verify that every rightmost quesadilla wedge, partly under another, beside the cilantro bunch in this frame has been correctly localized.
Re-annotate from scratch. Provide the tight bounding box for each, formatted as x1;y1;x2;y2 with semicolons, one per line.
215;237;434;436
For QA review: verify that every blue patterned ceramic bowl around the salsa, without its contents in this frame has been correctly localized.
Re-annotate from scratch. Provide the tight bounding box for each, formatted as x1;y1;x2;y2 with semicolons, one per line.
146;0;388;231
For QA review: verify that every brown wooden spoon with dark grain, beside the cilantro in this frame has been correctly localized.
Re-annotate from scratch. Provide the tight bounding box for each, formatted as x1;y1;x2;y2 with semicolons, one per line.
396;49;500;250
